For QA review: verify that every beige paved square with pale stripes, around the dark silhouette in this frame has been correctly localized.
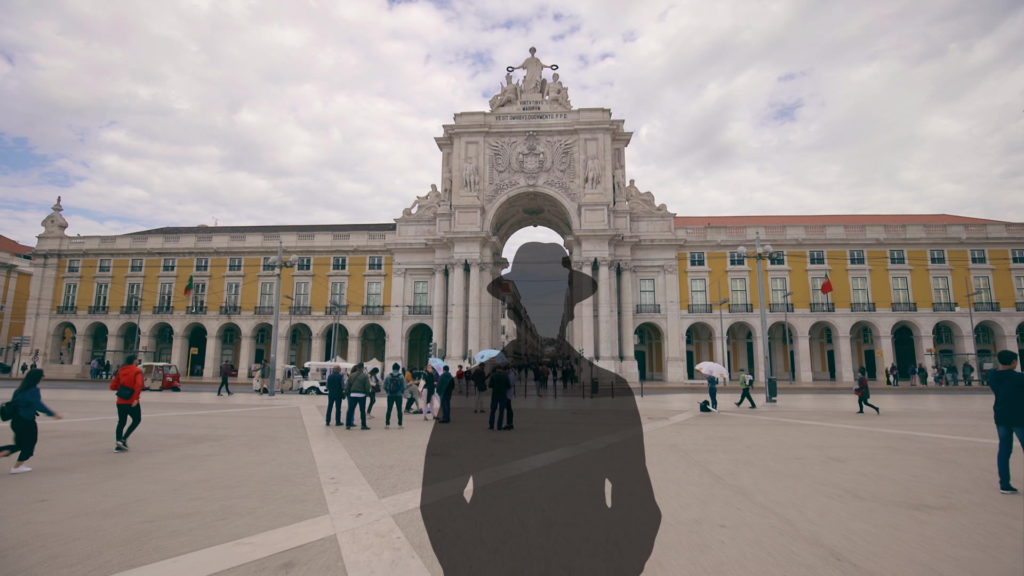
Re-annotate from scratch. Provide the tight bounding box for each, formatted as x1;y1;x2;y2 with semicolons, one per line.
0;382;1024;576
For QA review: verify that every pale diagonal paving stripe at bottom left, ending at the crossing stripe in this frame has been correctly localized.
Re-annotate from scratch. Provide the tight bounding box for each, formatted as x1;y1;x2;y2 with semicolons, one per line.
114;515;334;576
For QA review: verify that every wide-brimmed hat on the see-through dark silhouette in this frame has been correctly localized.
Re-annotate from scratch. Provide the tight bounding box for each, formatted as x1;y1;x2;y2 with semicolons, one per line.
487;242;597;305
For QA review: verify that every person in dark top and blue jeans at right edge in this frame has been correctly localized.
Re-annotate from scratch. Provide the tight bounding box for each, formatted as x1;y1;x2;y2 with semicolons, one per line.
988;349;1024;494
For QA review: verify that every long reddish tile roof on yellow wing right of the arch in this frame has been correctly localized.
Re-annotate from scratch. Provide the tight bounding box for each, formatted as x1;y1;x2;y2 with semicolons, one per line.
676;214;1010;228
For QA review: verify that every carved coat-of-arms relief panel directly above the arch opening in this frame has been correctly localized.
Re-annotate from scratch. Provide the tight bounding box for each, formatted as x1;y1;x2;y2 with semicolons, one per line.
488;132;575;197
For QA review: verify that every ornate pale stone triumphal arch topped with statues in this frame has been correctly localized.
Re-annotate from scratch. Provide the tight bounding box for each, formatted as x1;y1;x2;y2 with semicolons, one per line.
390;48;681;381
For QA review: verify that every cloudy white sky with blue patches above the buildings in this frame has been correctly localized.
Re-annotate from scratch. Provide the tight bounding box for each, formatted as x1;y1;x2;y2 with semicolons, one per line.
0;0;1024;245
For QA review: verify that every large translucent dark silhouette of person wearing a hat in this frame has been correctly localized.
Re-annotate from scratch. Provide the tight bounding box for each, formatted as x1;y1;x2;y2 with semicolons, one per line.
420;243;662;576
